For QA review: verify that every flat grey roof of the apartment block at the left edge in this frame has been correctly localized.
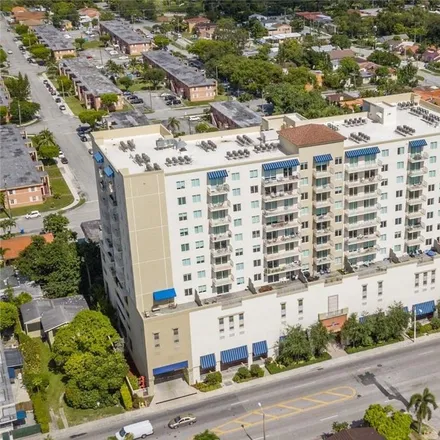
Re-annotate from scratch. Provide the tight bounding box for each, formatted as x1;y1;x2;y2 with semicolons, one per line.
0;125;42;189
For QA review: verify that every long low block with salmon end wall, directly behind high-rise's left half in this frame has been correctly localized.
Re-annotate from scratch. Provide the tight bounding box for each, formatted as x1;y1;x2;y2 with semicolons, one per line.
142;50;217;102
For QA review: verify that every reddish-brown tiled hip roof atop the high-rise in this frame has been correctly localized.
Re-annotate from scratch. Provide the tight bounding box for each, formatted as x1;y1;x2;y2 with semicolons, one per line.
280;124;345;147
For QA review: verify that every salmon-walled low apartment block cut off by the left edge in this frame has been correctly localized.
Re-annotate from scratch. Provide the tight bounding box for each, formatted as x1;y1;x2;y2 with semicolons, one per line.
0;125;51;210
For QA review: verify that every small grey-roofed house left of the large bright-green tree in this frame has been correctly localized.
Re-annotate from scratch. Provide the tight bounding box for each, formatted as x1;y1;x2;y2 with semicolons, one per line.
20;295;89;344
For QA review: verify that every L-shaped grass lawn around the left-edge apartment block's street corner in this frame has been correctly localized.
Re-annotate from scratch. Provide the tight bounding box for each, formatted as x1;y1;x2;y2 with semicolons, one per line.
0;165;74;218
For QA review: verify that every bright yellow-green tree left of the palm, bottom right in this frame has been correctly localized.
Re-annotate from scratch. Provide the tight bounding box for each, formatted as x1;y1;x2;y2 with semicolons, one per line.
364;404;412;440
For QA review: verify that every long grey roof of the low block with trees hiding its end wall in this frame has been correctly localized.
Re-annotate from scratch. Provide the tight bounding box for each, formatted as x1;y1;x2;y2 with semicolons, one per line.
60;58;121;96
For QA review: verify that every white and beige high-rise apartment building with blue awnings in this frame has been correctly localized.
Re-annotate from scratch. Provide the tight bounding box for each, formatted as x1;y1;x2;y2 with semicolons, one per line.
93;94;440;389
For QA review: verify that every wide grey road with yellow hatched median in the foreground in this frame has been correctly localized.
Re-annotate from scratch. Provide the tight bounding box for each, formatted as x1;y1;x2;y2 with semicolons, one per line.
37;339;440;440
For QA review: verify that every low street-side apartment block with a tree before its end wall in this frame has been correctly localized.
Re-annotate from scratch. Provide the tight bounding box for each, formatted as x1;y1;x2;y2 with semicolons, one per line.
59;58;124;110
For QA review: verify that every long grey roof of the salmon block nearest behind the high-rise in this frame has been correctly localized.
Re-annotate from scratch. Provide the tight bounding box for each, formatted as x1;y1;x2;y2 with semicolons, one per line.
142;50;216;87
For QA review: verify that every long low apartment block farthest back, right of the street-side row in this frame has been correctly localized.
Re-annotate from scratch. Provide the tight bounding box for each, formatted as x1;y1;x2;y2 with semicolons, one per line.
99;20;151;55
